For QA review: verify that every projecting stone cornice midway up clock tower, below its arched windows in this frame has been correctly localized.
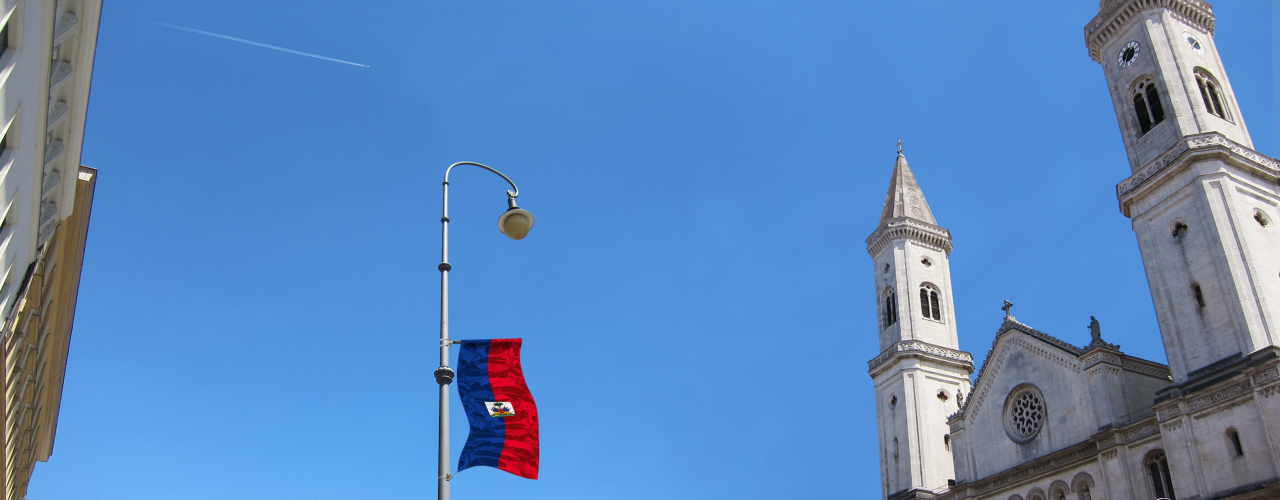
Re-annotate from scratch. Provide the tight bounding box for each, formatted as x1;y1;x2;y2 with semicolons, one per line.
1116;132;1280;216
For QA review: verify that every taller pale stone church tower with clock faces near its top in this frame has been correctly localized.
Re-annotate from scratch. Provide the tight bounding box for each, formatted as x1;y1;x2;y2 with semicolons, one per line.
1084;0;1280;384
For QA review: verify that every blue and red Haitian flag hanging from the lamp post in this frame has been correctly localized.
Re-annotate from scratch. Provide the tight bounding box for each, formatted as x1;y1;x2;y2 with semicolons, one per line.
457;339;538;480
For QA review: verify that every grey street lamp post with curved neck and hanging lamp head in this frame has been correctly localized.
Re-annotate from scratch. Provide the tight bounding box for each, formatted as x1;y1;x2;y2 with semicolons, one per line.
435;161;534;500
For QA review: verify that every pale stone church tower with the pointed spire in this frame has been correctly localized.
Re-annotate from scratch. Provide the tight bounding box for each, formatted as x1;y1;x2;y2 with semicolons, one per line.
867;150;973;500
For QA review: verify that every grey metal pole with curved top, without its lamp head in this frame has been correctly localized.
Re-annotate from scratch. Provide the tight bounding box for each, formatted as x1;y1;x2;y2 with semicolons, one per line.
435;161;520;500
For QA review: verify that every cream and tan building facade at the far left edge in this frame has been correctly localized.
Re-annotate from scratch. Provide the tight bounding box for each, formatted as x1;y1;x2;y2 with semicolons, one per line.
0;0;102;500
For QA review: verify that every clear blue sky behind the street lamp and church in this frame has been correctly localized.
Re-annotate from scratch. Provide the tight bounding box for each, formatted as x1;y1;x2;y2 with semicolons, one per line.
28;0;1277;500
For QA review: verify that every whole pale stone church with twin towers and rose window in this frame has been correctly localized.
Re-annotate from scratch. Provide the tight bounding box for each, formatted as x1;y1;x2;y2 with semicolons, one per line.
867;0;1280;500
